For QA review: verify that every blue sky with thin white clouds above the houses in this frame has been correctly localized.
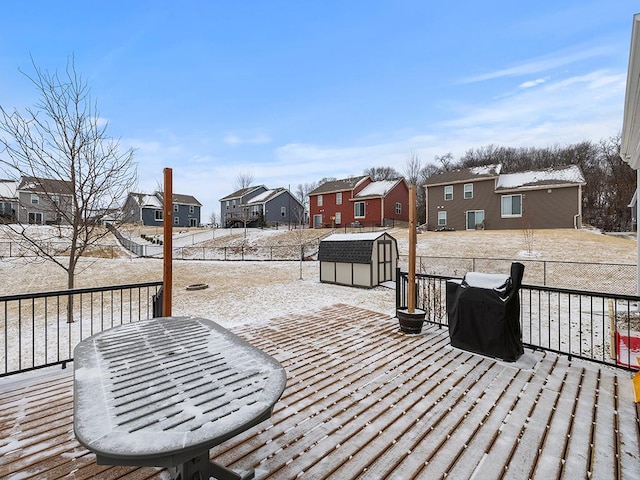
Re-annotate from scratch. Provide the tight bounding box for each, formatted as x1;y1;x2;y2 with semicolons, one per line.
0;0;640;216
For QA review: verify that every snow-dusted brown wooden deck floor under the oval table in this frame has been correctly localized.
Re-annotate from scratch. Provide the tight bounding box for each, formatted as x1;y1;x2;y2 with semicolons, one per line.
0;305;640;480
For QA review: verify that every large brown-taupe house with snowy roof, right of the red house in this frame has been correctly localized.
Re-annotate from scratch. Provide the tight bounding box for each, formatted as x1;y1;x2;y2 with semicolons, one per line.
425;164;586;230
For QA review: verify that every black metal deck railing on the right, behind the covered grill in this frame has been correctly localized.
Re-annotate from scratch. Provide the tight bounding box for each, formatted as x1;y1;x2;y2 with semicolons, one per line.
396;270;640;369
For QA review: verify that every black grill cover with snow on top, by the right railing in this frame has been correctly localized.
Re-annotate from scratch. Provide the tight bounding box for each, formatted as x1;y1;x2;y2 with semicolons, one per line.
447;262;524;362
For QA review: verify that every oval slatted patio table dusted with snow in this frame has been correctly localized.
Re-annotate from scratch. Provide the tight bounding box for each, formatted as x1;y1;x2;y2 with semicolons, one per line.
74;317;286;480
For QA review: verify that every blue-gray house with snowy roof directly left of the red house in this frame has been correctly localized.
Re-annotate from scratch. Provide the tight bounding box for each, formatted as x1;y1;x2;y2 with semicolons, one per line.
245;187;305;226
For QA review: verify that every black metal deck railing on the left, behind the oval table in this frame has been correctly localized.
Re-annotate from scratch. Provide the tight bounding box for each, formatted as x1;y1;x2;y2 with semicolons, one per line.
0;282;162;377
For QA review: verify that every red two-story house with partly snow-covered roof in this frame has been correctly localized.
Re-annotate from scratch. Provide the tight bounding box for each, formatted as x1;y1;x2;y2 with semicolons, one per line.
309;175;409;228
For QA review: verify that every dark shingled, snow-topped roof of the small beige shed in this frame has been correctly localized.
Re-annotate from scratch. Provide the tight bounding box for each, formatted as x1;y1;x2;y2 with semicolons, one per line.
318;232;393;263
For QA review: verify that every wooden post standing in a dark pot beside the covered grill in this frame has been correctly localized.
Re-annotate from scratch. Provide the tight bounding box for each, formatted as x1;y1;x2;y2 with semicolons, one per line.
396;183;426;334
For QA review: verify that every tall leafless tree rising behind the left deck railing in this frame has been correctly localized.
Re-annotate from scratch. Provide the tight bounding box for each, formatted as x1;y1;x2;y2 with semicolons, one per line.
0;57;136;300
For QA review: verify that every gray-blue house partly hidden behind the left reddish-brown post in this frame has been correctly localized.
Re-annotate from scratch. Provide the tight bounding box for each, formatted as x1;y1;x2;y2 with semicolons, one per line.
122;192;202;227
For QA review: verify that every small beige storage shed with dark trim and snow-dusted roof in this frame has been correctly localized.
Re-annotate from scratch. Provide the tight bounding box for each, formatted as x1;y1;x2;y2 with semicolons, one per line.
318;232;398;288
